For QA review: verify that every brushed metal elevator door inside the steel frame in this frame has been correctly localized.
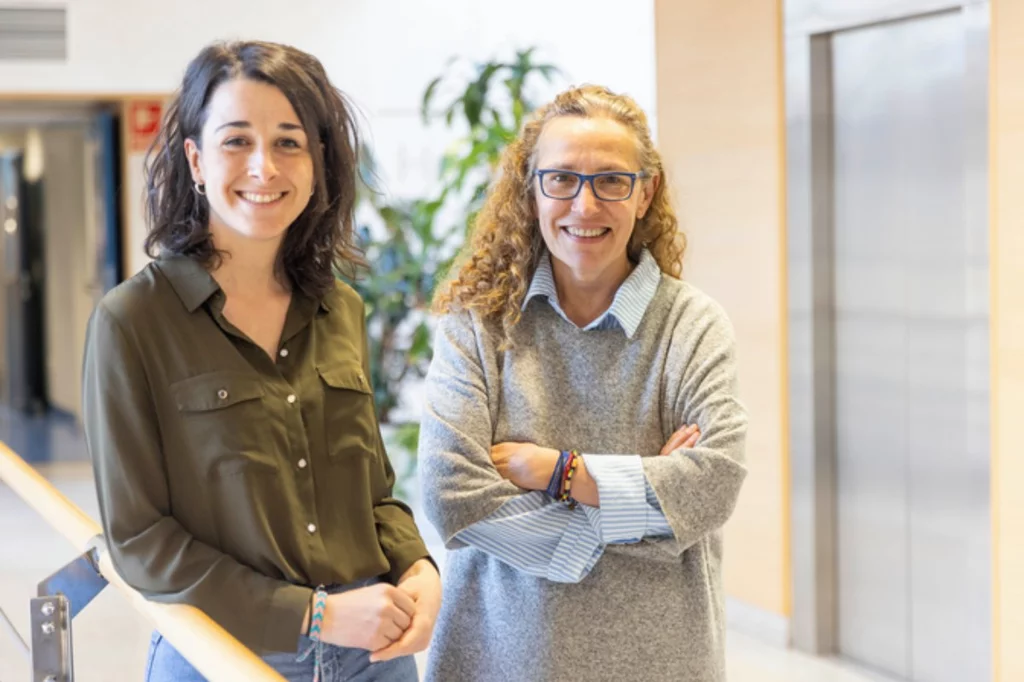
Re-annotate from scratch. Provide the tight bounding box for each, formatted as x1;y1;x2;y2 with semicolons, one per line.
833;12;990;682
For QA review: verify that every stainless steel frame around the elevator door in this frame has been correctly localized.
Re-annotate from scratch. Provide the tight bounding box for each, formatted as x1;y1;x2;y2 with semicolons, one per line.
784;0;989;654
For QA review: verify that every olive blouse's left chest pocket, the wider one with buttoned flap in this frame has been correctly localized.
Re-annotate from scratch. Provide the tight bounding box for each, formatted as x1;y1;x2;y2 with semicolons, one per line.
171;372;278;476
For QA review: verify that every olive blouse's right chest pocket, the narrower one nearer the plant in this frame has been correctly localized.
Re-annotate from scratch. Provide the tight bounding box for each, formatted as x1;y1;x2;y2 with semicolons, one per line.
316;363;378;461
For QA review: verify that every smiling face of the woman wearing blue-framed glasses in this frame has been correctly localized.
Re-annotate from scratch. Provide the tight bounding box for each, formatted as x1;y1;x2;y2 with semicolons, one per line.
532;116;657;286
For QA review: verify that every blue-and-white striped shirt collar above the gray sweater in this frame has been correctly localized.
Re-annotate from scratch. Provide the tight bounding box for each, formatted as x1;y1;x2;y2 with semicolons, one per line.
522;249;662;339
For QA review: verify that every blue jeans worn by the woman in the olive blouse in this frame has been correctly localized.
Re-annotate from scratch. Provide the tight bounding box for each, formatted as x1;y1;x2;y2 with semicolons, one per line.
145;579;420;682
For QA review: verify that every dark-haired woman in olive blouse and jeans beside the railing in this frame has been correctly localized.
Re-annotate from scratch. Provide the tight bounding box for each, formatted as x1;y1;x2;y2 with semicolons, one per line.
84;42;440;681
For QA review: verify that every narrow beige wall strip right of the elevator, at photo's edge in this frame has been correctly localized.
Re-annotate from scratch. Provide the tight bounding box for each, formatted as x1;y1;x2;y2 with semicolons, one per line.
990;0;1024;682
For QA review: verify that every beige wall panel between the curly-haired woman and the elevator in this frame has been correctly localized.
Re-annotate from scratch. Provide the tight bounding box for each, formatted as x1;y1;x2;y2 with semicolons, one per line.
654;0;790;615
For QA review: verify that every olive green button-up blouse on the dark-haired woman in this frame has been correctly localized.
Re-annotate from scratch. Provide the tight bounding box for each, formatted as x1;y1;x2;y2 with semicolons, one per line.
83;257;429;653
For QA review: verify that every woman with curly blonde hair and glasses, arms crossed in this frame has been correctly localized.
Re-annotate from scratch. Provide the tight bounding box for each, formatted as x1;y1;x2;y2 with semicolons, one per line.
420;86;746;682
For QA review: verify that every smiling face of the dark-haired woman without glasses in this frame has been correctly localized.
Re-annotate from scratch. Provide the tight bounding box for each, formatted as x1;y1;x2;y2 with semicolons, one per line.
185;79;314;243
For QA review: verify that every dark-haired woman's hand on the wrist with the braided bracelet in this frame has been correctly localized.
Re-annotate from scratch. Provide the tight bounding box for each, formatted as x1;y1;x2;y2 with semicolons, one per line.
321;583;416;651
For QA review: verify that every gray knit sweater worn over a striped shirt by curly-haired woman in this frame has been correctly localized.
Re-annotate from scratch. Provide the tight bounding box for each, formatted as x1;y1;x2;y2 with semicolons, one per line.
420;275;746;682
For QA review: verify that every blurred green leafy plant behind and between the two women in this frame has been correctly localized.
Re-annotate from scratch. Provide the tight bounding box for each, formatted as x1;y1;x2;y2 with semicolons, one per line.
350;48;558;496
